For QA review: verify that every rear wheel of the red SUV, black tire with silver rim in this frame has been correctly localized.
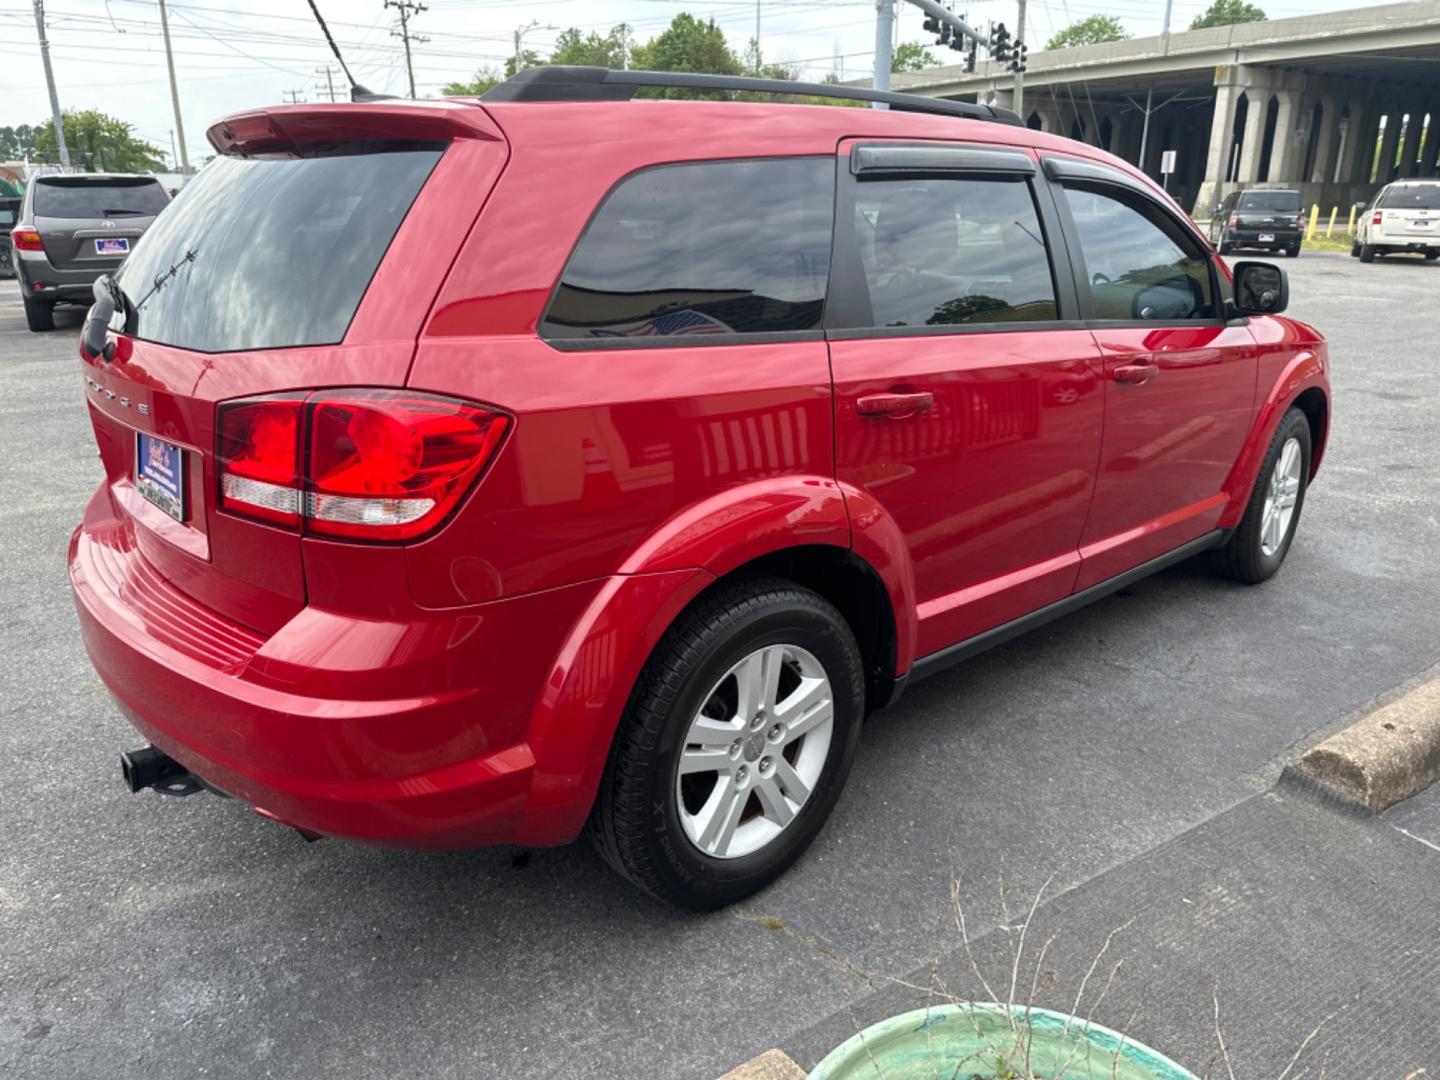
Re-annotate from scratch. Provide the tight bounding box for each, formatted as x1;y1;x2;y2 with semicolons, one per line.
588;579;865;910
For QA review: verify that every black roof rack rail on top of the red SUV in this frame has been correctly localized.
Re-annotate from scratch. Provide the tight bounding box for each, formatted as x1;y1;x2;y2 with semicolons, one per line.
481;65;1020;125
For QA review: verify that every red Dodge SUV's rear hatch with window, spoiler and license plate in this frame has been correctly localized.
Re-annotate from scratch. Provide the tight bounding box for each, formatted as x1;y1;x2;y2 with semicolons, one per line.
84;105;504;634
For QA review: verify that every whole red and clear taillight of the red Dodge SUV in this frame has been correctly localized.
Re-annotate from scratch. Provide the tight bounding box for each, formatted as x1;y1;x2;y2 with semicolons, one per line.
216;390;510;540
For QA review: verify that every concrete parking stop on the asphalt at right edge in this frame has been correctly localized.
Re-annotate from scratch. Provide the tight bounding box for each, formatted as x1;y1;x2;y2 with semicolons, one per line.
1300;678;1440;814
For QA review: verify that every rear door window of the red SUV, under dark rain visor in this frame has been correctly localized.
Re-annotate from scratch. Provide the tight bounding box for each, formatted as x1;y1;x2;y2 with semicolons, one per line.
854;176;1057;327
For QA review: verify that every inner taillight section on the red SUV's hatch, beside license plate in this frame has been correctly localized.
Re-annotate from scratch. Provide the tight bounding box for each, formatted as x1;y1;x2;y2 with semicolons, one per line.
215;396;304;527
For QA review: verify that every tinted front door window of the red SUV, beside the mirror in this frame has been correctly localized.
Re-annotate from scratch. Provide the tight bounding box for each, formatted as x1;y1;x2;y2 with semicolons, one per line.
1064;184;1215;321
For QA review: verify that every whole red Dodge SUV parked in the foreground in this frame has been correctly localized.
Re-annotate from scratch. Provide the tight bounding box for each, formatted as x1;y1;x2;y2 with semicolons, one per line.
69;68;1329;907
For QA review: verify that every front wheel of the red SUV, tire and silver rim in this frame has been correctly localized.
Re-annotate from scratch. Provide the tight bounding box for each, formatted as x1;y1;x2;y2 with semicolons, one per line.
1212;409;1310;585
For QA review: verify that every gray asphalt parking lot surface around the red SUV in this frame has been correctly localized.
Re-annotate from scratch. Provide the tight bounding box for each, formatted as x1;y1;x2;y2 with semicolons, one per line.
0;252;1440;1080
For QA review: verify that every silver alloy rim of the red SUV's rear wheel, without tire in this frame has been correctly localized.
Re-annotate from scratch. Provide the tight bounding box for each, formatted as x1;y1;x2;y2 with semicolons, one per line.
675;645;835;858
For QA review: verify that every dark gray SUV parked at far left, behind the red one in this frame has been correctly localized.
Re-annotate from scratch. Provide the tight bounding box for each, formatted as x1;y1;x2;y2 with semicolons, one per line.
10;173;170;330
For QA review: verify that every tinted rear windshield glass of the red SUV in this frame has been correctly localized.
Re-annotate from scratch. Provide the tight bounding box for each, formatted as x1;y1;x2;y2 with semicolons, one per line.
115;143;445;353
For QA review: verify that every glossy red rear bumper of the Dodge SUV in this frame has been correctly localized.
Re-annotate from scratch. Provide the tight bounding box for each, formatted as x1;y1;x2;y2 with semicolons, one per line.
69;494;630;847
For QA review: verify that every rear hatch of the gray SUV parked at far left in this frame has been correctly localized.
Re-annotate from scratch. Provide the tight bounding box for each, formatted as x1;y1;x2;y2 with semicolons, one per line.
30;173;170;274
